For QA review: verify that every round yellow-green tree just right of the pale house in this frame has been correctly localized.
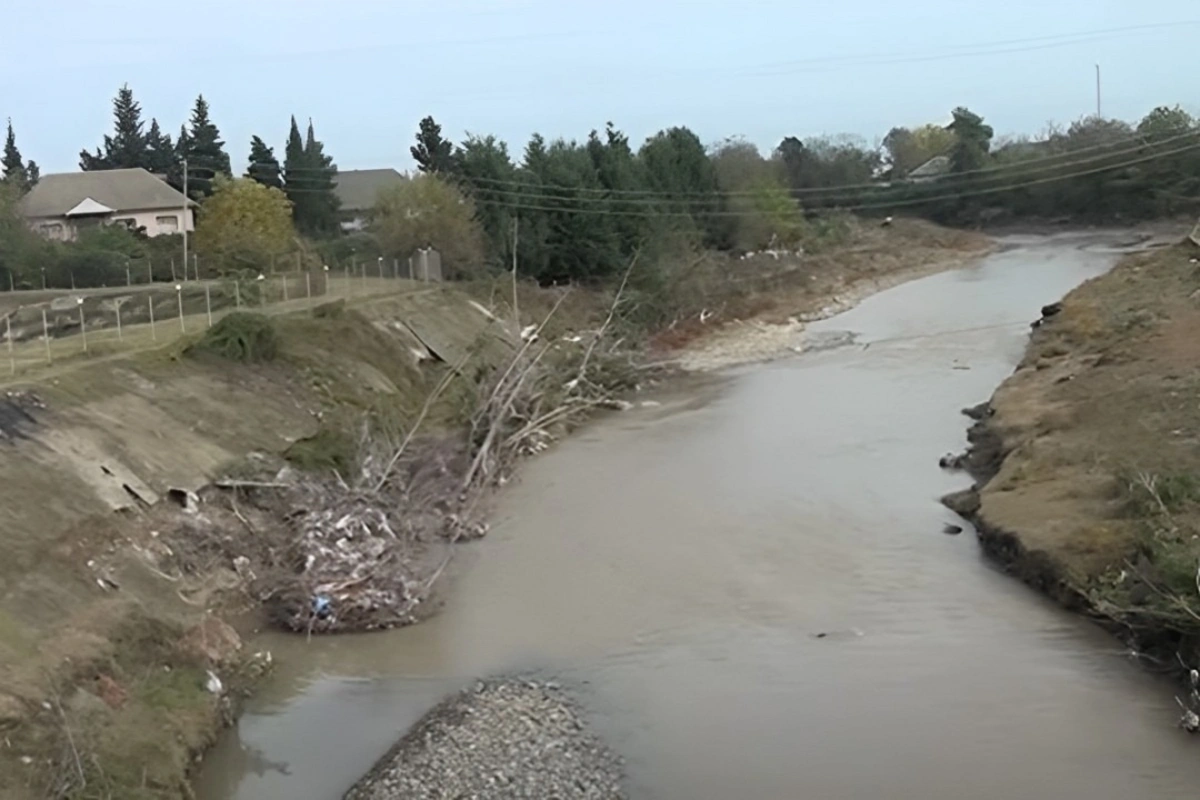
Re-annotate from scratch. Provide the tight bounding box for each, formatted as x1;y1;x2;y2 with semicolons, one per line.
194;175;295;271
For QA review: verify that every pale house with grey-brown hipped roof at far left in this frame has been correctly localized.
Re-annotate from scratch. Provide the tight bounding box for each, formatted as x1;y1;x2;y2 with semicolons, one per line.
20;168;196;241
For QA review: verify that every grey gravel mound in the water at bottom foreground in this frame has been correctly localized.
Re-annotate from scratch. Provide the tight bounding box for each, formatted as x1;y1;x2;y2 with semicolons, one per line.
346;679;625;800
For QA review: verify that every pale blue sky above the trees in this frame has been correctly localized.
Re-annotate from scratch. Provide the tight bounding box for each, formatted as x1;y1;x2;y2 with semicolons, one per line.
0;0;1200;174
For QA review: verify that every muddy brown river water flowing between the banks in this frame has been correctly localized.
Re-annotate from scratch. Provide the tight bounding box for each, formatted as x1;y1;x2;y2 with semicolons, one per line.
197;236;1200;800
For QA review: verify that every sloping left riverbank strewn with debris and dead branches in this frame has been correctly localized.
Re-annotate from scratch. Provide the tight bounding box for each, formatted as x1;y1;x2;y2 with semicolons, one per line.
0;215;978;798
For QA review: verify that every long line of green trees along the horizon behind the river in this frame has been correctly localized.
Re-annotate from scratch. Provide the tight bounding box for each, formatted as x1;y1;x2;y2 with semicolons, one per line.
0;86;1200;293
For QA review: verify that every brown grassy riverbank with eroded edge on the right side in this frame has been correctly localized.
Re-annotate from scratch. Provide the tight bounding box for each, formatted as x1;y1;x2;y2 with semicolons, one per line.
947;237;1200;669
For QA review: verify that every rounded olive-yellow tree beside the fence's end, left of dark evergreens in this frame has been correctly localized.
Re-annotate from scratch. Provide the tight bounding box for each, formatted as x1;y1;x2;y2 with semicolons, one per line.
371;174;485;278
